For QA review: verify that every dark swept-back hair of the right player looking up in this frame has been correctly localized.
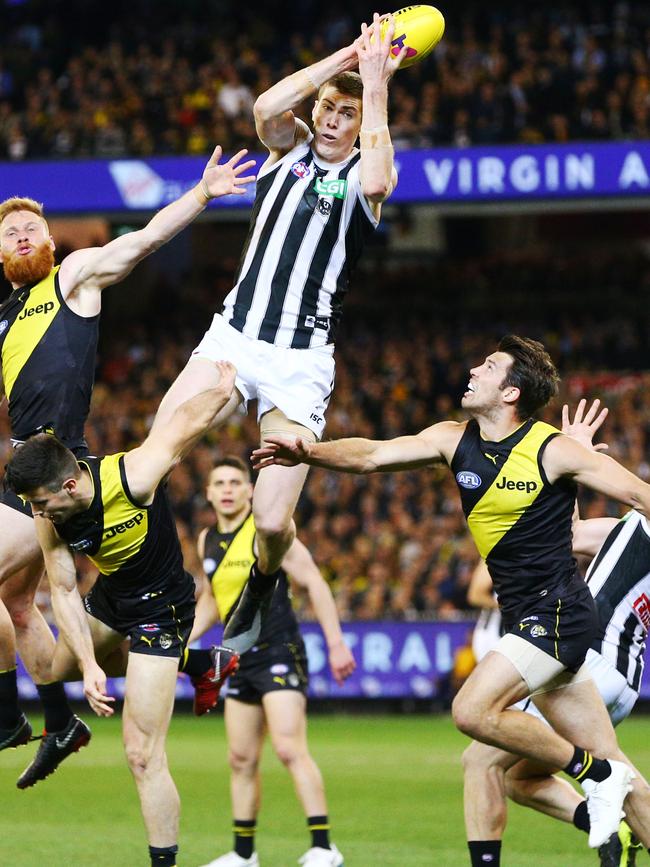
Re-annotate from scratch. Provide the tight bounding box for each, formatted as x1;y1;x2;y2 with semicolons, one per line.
498;334;560;419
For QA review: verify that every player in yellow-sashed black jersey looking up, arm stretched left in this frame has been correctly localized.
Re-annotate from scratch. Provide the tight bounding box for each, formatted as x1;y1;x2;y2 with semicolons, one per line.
254;336;650;867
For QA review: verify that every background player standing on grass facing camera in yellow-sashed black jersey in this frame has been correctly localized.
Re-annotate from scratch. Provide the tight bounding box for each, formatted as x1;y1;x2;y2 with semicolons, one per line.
192;457;355;867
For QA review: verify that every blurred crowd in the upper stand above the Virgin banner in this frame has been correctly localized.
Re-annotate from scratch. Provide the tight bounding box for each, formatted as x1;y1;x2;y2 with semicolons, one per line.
0;0;650;161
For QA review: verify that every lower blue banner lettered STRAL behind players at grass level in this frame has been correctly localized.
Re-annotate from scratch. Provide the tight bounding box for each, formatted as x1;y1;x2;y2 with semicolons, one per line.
18;621;650;699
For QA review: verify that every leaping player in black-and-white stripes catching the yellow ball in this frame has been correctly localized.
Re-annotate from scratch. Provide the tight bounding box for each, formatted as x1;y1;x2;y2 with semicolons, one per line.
154;14;404;653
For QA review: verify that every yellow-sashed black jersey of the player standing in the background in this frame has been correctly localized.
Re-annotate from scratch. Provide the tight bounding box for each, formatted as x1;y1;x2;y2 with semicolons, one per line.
203;513;299;644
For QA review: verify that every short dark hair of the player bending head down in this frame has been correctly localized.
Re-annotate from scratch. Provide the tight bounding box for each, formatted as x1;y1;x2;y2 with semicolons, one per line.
5;434;81;494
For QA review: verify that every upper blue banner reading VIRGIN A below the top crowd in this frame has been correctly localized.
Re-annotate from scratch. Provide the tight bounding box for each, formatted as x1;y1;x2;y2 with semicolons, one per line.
0;142;650;213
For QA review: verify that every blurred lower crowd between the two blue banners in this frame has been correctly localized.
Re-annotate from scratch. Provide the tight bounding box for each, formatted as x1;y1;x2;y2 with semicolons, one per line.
0;249;650;619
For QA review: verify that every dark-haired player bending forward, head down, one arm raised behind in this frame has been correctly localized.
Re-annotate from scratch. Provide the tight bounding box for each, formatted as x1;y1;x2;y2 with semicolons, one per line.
6;362;235;867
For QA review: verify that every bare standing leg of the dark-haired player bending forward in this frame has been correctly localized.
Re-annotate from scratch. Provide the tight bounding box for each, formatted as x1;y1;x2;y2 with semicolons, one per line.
122;653;180;867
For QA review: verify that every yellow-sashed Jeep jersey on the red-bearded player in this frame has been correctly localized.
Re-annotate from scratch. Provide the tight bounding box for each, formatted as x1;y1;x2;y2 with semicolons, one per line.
0;267;99;450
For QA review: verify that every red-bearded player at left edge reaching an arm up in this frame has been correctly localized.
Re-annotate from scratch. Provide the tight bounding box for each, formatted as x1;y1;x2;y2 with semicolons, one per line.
0;148;254;788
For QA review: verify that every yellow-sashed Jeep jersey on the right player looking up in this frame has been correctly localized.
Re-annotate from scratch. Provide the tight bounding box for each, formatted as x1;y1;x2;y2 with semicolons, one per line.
451;419;576;614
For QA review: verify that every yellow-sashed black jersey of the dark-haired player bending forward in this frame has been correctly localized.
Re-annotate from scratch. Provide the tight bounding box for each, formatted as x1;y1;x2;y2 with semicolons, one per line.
54;453;185;600
